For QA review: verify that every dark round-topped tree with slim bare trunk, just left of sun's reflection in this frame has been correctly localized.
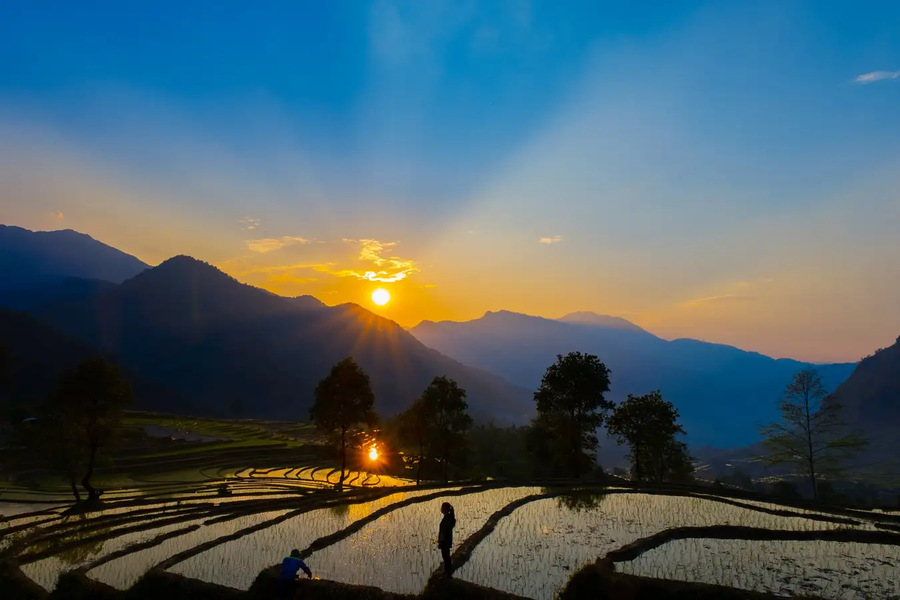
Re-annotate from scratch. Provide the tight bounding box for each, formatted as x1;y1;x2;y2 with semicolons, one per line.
309;356;378;490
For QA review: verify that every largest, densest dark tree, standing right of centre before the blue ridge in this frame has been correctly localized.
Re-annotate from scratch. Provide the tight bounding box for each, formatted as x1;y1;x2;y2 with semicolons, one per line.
532;352;613;477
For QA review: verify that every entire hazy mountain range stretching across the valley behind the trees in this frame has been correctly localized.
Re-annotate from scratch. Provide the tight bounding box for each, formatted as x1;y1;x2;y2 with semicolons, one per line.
0;227;897;447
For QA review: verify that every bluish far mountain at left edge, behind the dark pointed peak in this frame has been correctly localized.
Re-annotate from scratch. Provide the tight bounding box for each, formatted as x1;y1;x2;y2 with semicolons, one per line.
0;225;148;290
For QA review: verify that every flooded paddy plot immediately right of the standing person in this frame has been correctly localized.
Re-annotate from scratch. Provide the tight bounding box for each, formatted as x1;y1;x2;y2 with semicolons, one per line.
457;493;873;599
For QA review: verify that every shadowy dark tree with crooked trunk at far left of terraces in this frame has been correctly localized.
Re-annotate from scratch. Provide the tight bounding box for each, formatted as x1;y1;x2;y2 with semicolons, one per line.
44;358;133;502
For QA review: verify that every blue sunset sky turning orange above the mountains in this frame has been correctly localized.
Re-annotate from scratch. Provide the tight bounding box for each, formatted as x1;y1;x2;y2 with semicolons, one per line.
0;0;900;362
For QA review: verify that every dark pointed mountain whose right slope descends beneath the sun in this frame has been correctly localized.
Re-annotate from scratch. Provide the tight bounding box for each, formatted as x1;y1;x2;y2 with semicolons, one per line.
0;256;531;423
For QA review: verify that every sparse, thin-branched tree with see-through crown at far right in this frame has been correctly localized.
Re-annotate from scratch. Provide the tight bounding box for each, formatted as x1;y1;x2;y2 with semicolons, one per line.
760;368;868;500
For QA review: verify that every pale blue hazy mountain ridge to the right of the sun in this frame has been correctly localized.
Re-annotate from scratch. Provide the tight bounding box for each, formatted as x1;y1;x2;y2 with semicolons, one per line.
410;311;854;447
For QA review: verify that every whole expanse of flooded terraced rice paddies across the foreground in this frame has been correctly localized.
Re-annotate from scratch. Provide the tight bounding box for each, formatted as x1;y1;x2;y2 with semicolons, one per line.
0;482;900;600
